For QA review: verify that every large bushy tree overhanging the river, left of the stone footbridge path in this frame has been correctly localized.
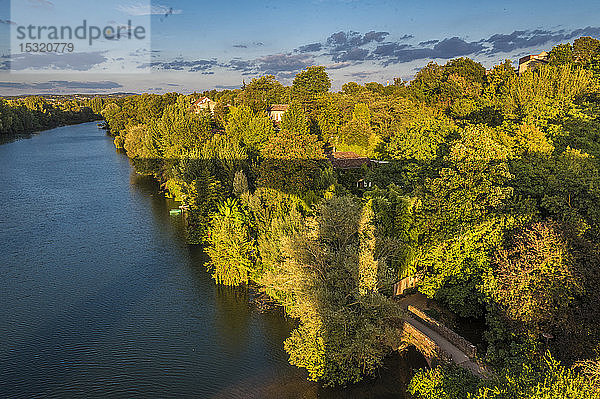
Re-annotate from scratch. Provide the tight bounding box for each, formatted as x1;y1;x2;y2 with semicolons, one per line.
265;197;398;385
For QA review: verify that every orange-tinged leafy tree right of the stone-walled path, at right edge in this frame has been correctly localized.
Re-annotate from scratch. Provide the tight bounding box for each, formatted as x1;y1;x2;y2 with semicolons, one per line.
486;221;600;366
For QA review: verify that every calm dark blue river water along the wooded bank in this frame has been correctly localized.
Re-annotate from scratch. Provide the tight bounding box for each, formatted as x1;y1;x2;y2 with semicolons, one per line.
0;123;423;398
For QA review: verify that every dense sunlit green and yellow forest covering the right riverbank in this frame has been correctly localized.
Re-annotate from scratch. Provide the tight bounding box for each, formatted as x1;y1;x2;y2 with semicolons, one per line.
96;37;600;399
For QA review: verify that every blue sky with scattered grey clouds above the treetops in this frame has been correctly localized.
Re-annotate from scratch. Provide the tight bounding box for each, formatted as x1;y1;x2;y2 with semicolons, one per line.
0;0;600;95
